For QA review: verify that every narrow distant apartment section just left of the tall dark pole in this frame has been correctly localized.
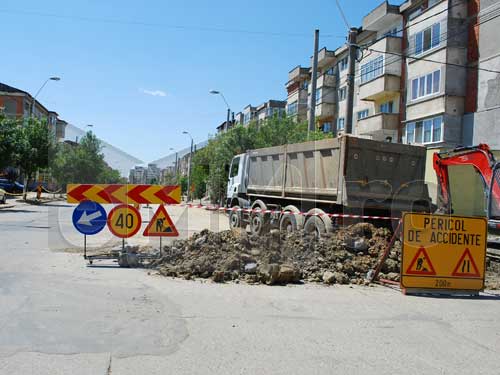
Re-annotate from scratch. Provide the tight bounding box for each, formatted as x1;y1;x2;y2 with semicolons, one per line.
286;65;311;121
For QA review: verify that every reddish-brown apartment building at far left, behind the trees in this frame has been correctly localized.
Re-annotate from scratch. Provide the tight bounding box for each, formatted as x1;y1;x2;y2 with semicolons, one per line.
0;83;67;140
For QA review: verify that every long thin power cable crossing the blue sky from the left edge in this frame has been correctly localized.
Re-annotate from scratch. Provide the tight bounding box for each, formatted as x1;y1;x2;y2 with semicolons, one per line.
0;9;345;39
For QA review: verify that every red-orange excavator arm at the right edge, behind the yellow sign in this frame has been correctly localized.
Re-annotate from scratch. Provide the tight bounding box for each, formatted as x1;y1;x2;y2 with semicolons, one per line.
433;144;500;244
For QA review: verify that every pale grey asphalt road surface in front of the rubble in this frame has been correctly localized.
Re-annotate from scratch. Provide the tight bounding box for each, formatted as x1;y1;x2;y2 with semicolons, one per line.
0;201;500;375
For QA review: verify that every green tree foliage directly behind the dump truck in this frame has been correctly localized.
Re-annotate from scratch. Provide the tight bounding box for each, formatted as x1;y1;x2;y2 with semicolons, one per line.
192;117;328;202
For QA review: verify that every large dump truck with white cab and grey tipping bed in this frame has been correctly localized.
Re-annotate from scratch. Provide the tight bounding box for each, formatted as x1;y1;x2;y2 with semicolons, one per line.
225;135;433;235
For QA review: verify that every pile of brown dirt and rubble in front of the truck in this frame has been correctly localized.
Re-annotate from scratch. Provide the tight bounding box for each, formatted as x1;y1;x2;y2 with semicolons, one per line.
146;223;401;285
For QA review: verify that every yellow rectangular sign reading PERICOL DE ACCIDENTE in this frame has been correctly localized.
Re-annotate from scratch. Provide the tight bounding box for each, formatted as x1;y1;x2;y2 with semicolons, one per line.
401;213;488;290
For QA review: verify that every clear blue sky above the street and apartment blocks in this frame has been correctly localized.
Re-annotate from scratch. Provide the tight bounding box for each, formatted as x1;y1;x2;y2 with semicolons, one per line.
0;0;400;162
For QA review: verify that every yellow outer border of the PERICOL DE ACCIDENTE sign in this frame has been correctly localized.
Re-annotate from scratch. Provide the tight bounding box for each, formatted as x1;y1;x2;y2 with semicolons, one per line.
400;212;488;291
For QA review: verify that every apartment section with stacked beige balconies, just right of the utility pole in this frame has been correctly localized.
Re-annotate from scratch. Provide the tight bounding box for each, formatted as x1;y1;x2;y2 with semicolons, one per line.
354;2;403;141
